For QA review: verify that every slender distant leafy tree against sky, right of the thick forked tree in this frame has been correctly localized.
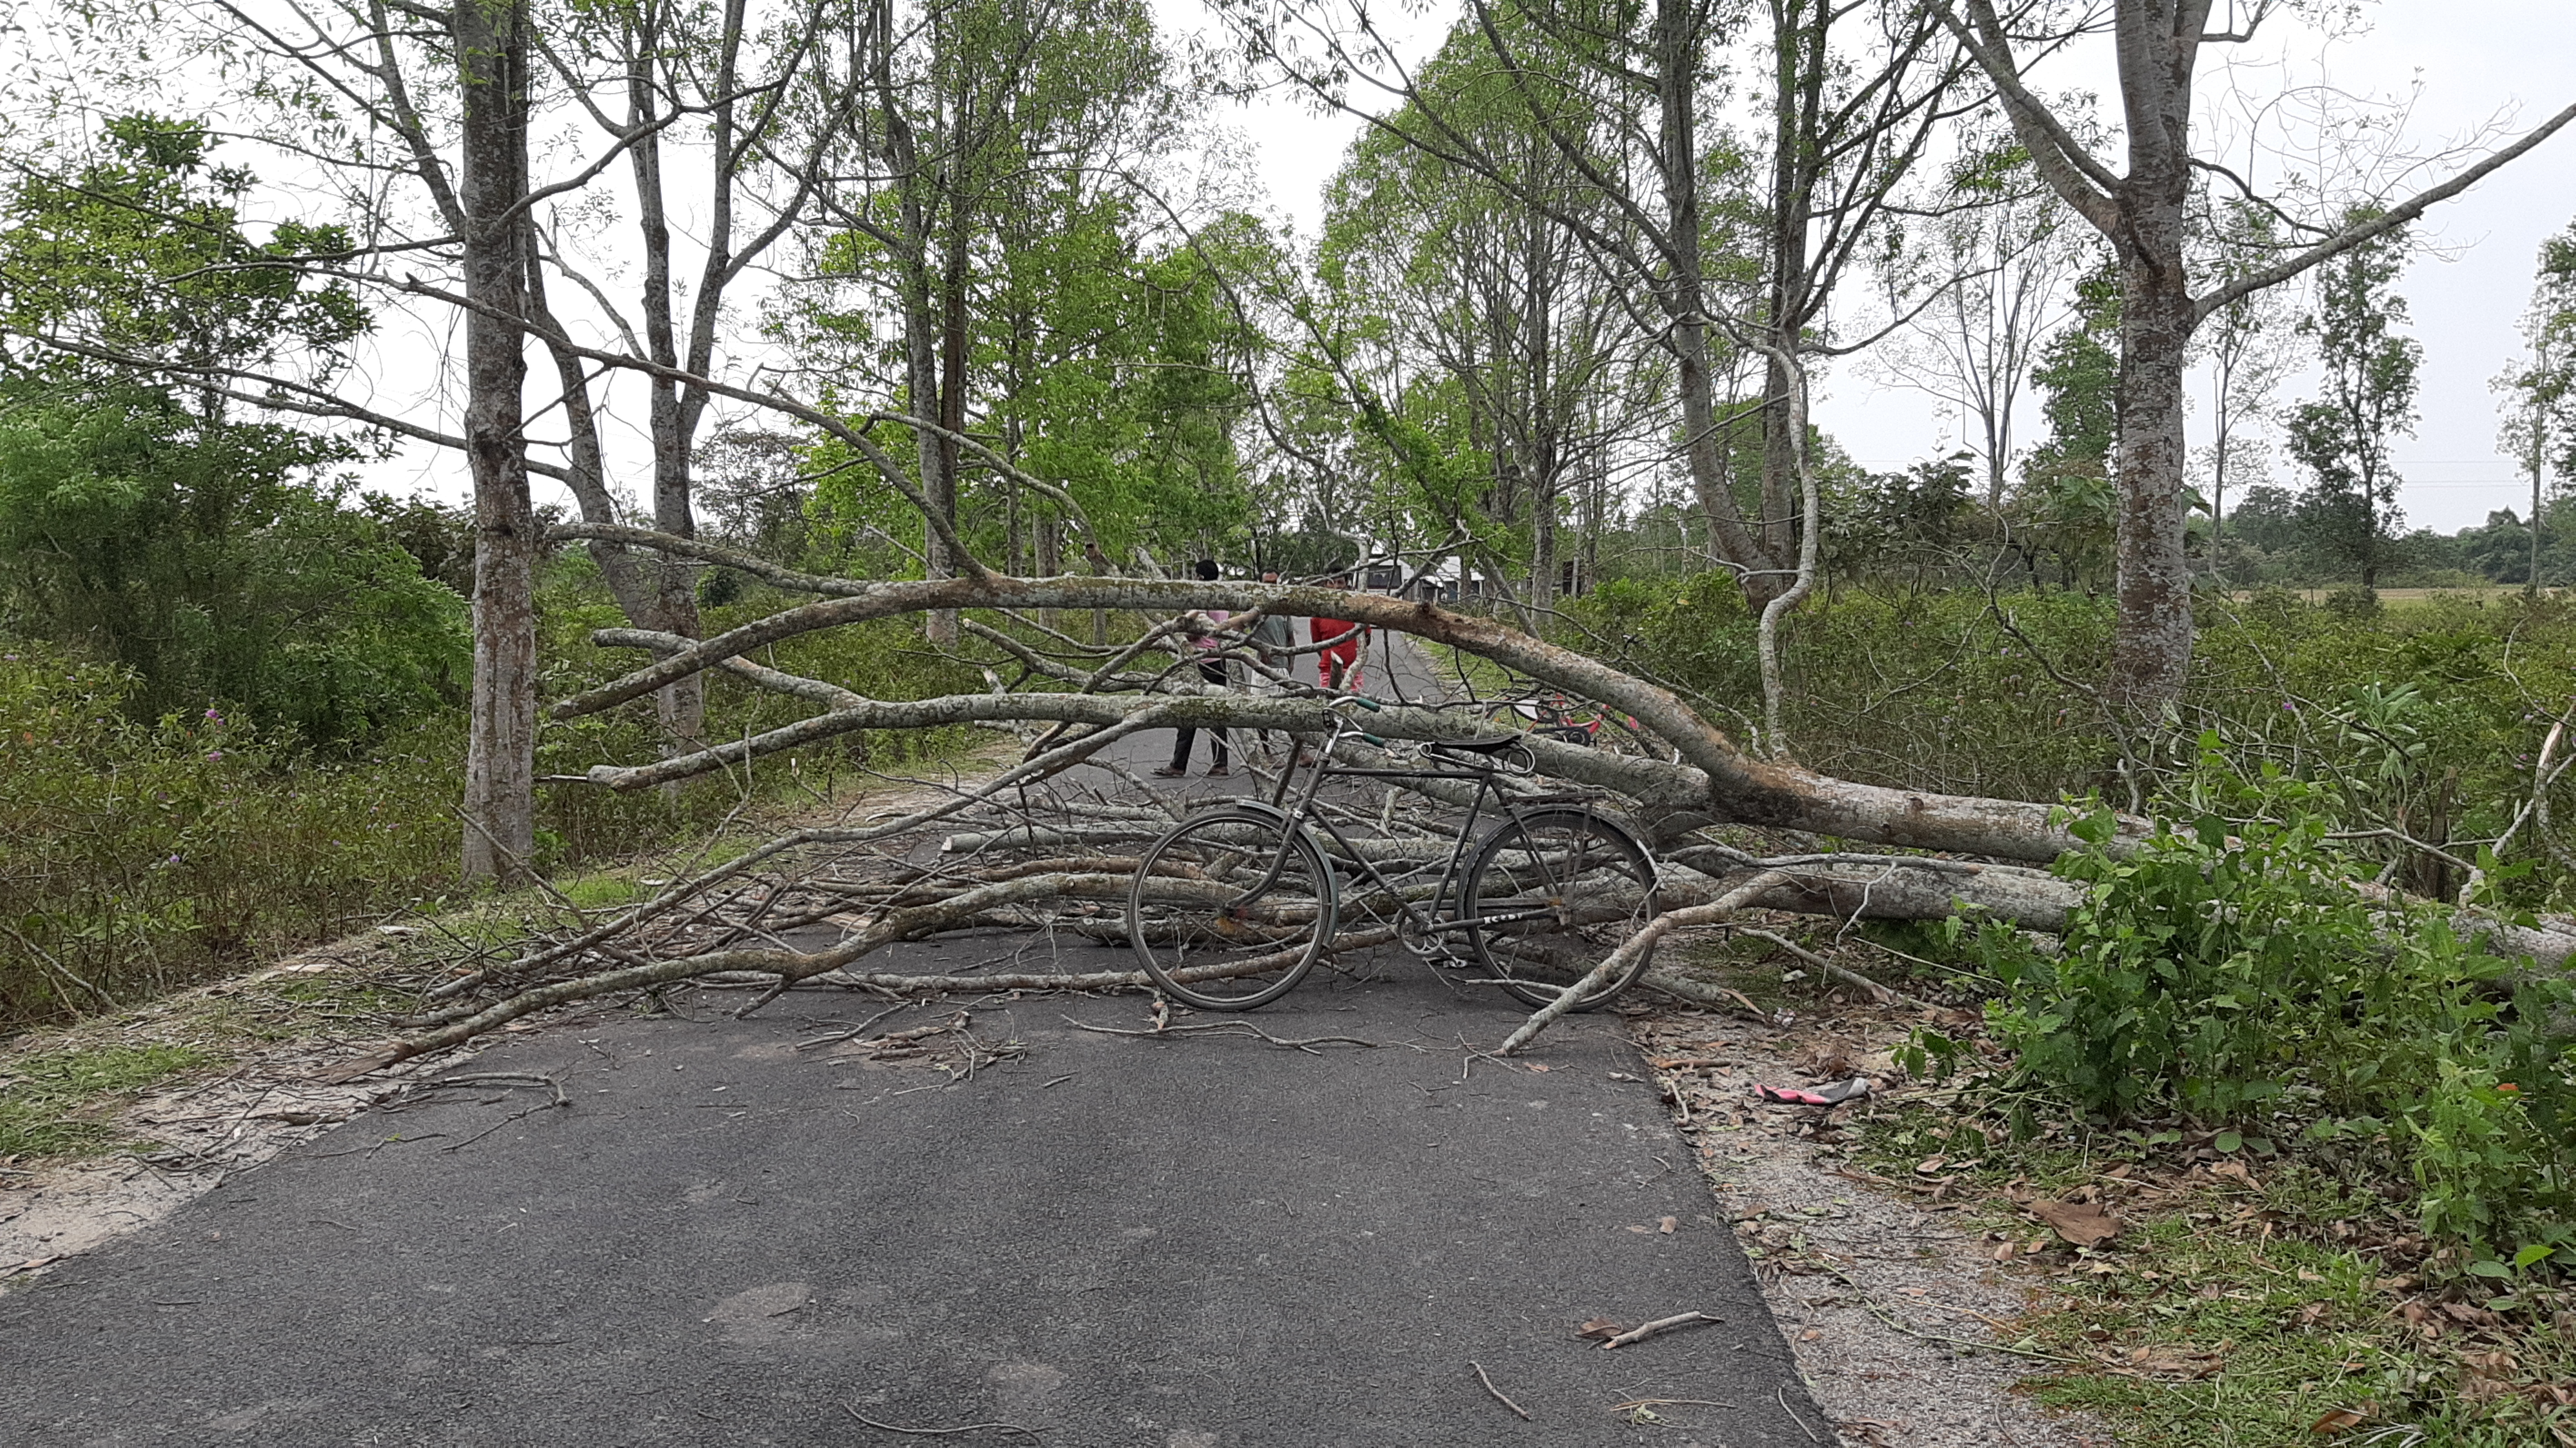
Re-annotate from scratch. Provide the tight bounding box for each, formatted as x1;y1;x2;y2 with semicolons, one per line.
2290;221;2424;588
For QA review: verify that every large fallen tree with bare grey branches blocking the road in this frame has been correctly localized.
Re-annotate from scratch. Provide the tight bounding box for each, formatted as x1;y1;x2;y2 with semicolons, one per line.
317;523;2576;1072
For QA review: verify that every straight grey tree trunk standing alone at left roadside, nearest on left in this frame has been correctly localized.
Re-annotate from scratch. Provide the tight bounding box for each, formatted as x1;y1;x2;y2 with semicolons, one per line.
453;0;536;881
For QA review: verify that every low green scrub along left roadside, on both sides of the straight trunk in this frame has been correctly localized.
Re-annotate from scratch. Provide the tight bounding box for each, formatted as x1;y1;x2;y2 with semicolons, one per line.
0;554;981;1031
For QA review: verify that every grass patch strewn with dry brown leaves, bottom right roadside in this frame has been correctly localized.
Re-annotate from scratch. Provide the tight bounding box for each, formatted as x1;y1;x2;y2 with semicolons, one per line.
1852;1103;2576;1448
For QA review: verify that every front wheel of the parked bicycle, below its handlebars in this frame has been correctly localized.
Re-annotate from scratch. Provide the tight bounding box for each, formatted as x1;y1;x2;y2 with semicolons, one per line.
1128;809;1334;1010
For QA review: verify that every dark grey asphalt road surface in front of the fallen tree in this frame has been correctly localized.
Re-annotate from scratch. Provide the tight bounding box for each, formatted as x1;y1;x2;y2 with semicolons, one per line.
0;940;1831;1448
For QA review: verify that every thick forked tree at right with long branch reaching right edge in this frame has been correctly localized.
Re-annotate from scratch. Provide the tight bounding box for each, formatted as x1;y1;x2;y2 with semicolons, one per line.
1932;0;2576;711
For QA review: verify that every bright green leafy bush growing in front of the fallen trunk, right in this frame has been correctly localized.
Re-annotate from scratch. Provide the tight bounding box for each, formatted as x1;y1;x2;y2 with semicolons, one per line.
1983;734;2576;1260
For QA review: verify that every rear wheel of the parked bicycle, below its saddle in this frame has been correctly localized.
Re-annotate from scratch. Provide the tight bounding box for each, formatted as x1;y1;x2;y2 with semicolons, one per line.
1460;809;1659;1010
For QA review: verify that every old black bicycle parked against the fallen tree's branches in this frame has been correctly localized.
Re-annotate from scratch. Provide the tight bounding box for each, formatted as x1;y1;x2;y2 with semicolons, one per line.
1126;696;1659;1010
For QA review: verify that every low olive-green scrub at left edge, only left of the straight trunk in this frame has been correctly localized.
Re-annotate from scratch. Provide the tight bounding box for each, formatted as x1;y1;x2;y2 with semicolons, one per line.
0;644;461;1023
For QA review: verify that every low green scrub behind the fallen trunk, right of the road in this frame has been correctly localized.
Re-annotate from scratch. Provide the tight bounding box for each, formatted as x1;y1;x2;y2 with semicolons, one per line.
1597;574;2576;910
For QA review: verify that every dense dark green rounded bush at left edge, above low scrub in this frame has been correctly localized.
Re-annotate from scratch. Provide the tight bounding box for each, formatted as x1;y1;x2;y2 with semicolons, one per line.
0;392;466;744
